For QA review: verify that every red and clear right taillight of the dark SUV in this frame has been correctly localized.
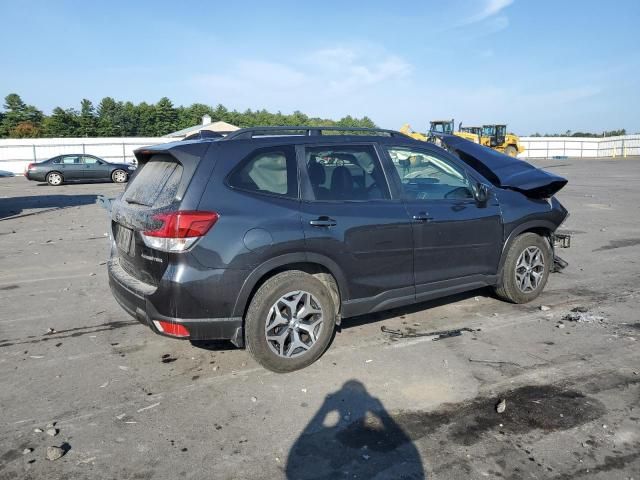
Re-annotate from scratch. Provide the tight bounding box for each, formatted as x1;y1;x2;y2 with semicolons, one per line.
142;211;220;252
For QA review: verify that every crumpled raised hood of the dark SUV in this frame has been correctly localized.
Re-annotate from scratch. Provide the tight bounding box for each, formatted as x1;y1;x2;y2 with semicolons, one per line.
439;135;568;198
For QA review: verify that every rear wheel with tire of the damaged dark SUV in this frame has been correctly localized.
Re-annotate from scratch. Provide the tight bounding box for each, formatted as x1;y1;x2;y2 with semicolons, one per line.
245;270;337;373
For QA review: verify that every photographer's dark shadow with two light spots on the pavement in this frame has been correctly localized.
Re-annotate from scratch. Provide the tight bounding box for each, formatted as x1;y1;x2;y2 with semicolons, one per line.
286;380;426;480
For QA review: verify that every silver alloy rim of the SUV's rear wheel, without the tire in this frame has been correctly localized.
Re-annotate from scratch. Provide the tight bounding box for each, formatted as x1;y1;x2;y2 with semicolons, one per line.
264;291;324;358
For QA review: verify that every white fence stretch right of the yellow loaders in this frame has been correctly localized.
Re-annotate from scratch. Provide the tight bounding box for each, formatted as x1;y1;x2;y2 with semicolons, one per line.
518;135;640;158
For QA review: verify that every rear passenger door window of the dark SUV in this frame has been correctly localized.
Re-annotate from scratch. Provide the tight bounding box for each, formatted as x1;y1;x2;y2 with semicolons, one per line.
305;145;390;200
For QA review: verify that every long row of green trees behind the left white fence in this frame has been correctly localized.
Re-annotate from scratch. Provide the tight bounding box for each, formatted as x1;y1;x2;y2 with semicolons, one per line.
0;93;376;138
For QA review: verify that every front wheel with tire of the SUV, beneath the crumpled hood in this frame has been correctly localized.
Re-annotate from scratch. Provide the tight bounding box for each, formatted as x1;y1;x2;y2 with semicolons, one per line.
495;232;553;303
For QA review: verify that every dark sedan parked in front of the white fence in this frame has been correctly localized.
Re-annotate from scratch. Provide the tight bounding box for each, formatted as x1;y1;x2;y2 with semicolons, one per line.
24;153;135;186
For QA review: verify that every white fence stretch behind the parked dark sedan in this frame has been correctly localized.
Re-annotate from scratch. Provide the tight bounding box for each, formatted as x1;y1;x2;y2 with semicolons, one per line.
0;137;170;174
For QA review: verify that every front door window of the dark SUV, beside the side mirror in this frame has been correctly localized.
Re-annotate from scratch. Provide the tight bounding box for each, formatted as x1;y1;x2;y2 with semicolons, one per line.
388;147;473;200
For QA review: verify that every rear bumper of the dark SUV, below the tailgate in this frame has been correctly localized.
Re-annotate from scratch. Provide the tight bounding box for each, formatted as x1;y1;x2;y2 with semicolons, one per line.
108;259;244;347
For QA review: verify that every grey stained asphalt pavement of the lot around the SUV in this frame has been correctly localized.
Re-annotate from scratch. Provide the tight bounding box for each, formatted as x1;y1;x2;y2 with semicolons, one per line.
0;158;640;480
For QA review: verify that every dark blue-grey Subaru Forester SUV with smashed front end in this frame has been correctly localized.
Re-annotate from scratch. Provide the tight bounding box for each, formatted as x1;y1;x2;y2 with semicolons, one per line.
108;127;567;372
